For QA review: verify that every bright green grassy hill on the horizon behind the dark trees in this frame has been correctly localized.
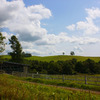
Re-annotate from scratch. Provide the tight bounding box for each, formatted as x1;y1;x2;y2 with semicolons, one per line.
2;55;100;62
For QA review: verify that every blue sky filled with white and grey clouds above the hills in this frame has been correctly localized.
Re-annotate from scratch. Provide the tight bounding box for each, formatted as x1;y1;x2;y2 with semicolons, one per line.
0;0;100;56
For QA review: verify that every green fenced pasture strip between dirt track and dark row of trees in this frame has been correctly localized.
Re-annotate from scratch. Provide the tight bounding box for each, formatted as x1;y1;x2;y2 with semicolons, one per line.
12;72;100;91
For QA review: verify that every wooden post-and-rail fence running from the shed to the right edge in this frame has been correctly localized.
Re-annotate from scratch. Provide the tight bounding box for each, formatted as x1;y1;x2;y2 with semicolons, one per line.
12;72;100;86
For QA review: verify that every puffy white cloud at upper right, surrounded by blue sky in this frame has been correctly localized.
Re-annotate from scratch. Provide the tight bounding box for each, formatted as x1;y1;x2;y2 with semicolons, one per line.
67;8;100;35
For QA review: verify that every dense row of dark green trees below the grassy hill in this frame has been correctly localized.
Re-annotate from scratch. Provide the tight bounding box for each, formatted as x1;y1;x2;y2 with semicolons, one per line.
29;58;100;74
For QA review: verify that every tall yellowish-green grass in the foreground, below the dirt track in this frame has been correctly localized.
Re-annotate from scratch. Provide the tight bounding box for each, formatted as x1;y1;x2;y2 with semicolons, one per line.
0;74;100;100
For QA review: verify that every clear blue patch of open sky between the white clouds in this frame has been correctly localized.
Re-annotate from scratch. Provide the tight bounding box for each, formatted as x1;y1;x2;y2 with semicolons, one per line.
24;0;100;34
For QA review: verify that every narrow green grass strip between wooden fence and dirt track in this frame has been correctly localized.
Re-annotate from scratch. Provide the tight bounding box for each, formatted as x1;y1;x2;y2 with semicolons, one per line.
22;77;100;91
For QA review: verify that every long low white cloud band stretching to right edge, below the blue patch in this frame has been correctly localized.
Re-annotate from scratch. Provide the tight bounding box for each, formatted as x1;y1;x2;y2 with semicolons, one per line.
35;32;100;45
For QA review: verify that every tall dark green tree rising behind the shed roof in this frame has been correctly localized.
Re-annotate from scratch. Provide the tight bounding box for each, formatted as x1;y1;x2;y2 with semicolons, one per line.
9;35;23;62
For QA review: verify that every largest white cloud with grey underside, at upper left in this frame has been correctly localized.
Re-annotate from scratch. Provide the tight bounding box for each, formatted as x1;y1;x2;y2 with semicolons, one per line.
0;0;52;41
